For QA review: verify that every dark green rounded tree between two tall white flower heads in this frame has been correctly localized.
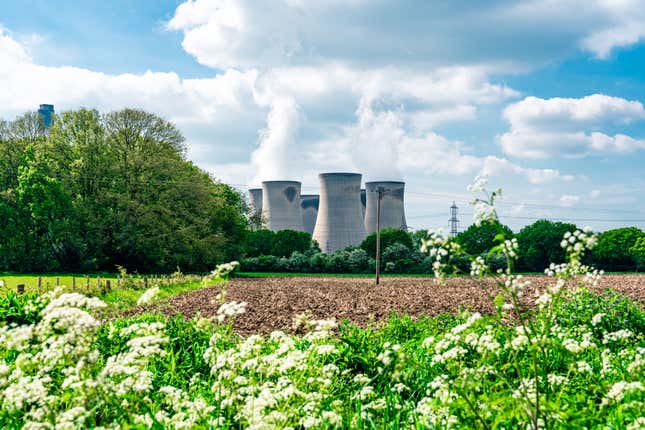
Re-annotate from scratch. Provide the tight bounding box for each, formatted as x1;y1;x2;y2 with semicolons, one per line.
516;220;577;272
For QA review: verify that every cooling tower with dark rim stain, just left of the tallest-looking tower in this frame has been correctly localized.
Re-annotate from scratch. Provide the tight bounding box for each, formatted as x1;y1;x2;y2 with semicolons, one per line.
262;181;303;231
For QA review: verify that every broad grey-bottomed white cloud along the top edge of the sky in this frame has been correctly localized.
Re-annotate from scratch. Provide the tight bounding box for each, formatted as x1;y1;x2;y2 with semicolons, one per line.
168;0;645;71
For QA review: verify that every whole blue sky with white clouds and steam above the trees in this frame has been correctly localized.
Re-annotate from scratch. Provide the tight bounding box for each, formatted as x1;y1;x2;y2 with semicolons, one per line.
0;0;645;230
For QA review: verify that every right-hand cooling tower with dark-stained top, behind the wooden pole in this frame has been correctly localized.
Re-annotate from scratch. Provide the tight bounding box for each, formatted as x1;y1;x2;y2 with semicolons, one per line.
365;181;407;234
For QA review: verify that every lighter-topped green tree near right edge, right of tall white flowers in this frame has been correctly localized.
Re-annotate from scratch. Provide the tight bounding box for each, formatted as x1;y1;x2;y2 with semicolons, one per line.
592;227;645;271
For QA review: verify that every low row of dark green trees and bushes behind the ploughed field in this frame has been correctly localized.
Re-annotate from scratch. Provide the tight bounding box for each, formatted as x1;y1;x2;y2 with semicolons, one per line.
241;220;645;274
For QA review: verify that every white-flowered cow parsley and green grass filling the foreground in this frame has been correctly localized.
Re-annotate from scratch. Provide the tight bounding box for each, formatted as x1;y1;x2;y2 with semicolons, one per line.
0;278;645;429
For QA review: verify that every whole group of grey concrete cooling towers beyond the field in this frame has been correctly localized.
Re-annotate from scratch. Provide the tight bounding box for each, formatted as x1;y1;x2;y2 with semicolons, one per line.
249;173;407;253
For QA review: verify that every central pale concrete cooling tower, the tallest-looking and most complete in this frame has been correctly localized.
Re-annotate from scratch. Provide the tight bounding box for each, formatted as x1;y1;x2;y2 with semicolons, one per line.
313;173;365;253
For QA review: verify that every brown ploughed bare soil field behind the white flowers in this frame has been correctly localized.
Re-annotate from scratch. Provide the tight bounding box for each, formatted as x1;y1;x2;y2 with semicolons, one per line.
132;274;645;334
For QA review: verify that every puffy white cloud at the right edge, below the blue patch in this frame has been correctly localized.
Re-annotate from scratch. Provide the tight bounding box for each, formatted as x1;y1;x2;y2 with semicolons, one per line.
500;94;645;159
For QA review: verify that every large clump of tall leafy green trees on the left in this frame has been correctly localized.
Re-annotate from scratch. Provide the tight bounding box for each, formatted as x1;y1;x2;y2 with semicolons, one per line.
0;109;247;272
